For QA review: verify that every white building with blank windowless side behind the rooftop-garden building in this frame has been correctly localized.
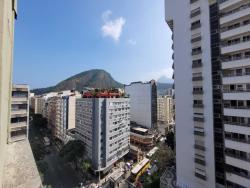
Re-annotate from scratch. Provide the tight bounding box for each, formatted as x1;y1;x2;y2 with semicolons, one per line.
125;80;157;129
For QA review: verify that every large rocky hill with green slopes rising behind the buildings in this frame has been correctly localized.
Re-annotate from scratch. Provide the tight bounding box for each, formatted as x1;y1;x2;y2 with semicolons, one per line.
31;69;123;95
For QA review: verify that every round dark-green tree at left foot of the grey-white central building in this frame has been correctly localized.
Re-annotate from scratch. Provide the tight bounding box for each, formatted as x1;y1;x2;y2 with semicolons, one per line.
60;140;85;170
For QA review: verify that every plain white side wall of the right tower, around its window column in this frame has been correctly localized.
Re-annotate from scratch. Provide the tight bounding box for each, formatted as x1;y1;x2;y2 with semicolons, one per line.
165;0;215;188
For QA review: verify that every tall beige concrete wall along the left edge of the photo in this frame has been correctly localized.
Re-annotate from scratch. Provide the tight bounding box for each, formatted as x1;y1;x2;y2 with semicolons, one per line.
0;0;15;187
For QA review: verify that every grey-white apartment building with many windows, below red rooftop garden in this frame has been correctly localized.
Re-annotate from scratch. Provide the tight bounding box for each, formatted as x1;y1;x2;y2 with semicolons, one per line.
76;94;130;172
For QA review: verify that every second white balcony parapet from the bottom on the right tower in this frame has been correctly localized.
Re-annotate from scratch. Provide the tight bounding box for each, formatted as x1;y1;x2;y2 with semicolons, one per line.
226;153;250;171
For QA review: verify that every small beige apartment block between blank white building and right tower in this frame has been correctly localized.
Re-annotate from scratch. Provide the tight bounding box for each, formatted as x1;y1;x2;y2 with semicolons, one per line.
157;95;173;124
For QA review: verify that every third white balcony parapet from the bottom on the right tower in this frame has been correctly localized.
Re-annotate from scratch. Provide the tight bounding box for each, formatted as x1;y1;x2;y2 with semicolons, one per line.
225;138;250;153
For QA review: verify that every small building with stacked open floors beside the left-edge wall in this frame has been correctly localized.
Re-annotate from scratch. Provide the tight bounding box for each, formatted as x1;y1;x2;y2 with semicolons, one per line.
8;85;29;142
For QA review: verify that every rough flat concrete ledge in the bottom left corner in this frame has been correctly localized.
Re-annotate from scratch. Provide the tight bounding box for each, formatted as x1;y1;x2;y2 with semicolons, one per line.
3;140;42;188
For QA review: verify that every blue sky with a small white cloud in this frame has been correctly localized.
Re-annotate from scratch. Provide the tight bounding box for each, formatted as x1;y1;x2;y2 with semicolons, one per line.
13;0;172;88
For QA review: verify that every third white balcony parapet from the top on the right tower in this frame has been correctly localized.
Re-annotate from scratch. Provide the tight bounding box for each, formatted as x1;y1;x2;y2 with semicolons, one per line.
220;22;250;40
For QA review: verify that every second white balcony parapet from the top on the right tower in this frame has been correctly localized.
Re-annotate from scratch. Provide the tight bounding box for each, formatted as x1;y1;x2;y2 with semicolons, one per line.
220;0;250;24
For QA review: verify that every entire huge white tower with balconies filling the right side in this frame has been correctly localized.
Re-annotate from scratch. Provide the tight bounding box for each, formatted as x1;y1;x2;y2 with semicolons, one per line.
165;0;250;188
